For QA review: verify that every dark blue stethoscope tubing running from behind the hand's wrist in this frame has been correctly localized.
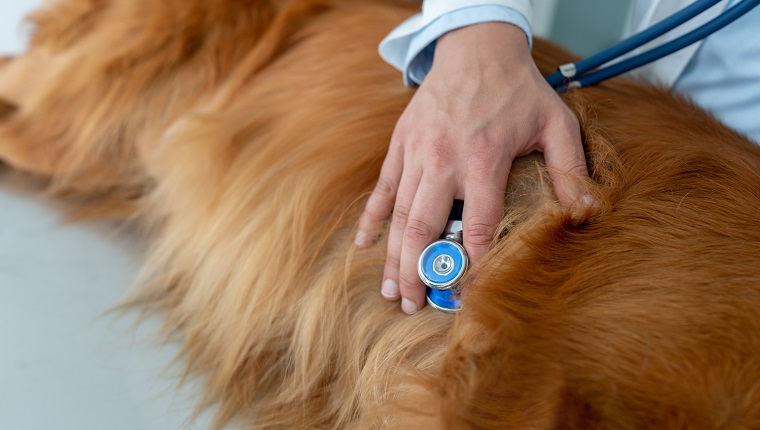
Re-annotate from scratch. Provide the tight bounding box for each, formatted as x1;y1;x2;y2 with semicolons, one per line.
546;0;760;92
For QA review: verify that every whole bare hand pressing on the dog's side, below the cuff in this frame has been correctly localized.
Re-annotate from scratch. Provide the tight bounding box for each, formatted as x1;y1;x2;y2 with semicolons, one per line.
356;23;588;314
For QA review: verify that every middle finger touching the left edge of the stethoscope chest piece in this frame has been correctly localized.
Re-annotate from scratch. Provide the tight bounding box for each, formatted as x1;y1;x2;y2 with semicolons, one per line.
399;175;455;314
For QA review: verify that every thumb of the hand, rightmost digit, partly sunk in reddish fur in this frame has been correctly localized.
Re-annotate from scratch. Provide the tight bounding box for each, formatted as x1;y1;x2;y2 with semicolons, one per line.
542;109;590;208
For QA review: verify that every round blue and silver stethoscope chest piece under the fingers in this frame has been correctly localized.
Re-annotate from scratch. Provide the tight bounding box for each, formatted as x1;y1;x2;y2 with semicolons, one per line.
417;200;469;312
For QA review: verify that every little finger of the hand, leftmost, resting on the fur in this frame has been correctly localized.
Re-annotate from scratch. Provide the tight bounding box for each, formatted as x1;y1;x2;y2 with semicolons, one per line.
354;143;404;246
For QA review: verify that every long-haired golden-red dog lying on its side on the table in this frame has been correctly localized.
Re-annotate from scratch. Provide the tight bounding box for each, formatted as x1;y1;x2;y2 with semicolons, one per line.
0;0;760;429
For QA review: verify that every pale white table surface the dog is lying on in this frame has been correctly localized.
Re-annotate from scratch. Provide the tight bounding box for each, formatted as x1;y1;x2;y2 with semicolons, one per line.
0;0;210;430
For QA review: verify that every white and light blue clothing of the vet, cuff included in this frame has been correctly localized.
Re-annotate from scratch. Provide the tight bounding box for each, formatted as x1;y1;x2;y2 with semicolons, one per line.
380;0;760;144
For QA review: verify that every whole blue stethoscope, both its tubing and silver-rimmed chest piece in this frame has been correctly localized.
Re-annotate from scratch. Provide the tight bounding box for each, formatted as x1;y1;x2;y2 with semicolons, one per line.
417;0;760;313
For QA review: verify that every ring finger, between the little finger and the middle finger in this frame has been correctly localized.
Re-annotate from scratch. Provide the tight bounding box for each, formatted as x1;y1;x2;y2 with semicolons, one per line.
380;168;422;301
